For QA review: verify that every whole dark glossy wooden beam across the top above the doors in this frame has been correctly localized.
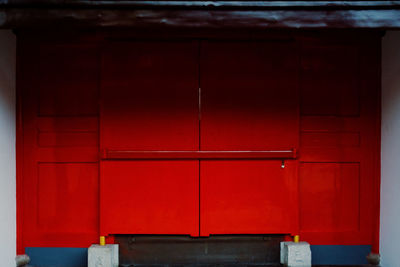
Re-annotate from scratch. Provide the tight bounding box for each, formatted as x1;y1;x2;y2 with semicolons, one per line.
0;0;400;29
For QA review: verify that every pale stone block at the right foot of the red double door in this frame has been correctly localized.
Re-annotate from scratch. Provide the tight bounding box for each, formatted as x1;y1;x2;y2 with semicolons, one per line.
281;242;311;267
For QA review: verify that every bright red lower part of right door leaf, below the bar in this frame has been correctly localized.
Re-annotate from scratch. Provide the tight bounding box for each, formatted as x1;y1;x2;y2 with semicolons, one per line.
200;160;297;236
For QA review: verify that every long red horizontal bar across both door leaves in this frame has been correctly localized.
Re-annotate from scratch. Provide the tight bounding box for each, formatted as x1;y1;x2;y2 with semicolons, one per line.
101;149;297;159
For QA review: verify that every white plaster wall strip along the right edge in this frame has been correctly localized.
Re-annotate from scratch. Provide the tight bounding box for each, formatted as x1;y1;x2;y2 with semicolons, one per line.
380;31;400;267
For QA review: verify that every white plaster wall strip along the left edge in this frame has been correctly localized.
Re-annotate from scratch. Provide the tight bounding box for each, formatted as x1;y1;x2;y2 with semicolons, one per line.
0;30;16;267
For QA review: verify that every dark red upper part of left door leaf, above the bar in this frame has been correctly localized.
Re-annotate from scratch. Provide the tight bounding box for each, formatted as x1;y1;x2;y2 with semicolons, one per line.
100;42;199;150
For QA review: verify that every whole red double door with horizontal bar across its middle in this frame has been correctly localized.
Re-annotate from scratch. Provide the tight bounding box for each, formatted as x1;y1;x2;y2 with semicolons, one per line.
100;41;299;236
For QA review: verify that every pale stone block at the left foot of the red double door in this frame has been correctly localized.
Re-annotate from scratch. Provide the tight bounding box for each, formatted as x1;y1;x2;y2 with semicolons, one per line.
88;245;119;267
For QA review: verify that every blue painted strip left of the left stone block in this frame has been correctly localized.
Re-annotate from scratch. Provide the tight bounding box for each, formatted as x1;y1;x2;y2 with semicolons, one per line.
25;247;87;267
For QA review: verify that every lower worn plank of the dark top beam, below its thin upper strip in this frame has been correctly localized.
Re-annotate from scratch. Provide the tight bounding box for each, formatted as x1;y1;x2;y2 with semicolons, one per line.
0;7;400;29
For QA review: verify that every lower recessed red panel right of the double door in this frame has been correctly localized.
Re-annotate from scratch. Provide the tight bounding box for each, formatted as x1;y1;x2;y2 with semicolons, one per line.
299;163;360;232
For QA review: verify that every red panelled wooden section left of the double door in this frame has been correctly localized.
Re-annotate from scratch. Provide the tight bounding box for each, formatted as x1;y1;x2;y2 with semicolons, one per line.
17;42;99;253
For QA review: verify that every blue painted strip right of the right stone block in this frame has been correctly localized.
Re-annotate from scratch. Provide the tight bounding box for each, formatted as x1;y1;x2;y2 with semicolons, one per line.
311;245;371;265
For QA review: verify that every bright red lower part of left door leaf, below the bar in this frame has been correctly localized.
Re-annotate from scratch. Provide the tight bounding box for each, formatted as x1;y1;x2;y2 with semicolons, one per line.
100;160;199;236
